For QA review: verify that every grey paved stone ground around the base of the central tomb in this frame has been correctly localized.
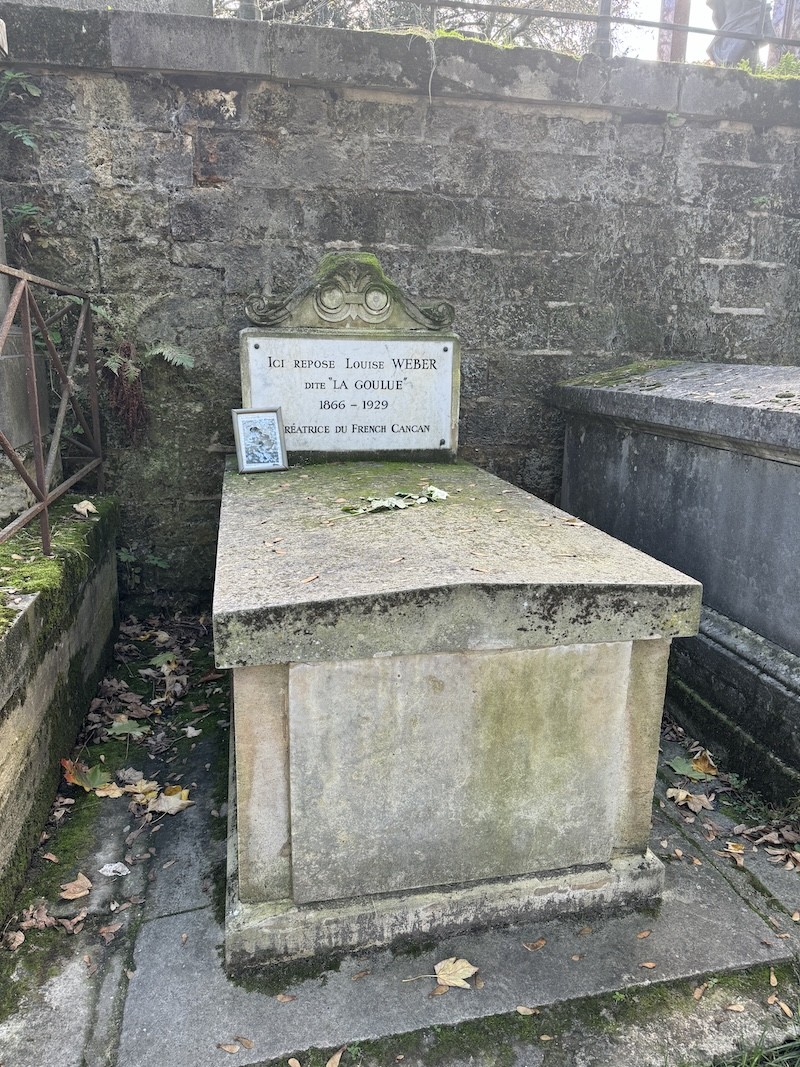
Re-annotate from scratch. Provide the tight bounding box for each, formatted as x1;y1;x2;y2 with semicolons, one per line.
0;644;800;1067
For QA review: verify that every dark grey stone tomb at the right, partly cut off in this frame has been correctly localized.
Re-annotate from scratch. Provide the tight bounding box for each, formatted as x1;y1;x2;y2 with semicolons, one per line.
557;363;800;800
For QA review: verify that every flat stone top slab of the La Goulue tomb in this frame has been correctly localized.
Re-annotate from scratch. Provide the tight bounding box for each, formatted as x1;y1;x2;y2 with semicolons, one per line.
213;462;701;667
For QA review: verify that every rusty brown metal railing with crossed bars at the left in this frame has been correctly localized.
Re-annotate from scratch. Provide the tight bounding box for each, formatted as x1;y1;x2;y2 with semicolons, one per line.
0;265;103;556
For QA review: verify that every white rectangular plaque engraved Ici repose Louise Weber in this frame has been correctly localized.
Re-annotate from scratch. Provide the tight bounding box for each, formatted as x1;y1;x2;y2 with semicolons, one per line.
241;329;459;455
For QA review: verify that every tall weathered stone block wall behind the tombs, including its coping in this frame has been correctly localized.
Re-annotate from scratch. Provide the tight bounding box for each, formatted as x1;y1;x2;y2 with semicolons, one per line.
0;4;800;588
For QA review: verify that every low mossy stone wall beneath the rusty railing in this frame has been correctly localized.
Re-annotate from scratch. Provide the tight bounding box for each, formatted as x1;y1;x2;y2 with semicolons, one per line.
0;497;118;922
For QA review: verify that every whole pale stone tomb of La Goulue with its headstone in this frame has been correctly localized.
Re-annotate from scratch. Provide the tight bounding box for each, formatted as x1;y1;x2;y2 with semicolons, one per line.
214;257;700;968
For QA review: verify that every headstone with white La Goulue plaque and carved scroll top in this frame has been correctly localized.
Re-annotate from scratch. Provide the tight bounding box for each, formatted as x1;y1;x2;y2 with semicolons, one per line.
241;254;459;458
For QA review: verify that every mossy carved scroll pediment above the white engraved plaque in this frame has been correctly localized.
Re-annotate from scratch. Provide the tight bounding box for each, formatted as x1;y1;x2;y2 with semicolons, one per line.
244;253;455;330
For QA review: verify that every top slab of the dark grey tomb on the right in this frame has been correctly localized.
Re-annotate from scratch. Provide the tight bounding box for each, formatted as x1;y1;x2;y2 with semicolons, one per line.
553;363;800;463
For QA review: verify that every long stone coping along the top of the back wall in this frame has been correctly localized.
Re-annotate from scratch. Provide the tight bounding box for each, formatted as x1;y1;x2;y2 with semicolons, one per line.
0;3;800;126
